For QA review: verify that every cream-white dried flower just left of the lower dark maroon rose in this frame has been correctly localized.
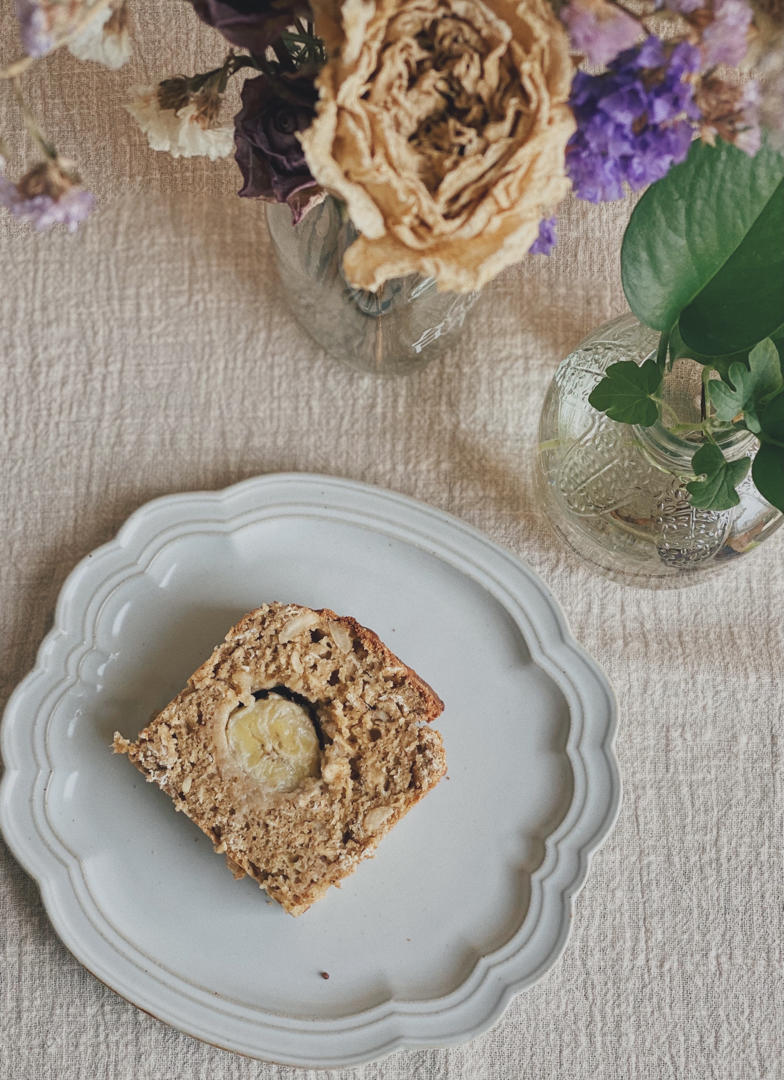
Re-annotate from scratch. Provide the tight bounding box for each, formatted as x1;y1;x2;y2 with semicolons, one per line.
125;86;234;161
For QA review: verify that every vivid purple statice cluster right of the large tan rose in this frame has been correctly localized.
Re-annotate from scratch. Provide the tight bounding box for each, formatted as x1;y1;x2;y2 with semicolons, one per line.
566;36;700;202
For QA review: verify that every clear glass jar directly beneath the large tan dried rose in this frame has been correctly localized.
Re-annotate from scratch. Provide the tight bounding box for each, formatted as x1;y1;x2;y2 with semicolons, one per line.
267;197;479;375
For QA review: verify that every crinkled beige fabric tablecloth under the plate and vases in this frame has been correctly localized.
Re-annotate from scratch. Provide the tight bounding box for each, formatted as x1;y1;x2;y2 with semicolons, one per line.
0;0;784;1080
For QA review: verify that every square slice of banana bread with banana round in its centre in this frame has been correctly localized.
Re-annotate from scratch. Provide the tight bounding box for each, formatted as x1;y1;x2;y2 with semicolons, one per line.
113;604;446;915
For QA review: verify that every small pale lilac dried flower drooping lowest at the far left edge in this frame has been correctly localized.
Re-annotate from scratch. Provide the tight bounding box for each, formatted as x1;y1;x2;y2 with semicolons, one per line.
0;161;95;232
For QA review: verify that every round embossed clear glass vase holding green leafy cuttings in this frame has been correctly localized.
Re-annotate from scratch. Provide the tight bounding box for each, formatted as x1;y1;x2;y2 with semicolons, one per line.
537;315;784;588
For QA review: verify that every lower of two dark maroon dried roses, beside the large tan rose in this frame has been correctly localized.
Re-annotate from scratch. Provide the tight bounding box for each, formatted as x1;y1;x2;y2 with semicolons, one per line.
234;68;319;221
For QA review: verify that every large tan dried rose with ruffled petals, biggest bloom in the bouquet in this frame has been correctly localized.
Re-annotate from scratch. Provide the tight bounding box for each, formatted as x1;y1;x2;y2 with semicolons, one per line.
302;0;575;292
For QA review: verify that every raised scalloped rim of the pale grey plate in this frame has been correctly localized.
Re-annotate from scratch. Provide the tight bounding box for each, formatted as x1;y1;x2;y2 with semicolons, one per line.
0;472;622;1068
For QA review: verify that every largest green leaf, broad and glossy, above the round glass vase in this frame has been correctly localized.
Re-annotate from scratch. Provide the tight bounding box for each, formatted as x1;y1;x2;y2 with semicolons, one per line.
621;140;784;356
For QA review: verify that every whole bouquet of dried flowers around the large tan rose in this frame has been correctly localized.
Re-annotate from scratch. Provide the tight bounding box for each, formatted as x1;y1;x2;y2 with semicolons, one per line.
0;0;784;375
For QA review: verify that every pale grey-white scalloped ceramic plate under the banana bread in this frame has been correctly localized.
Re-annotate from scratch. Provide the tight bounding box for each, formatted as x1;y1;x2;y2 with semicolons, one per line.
0;474;620;1067
